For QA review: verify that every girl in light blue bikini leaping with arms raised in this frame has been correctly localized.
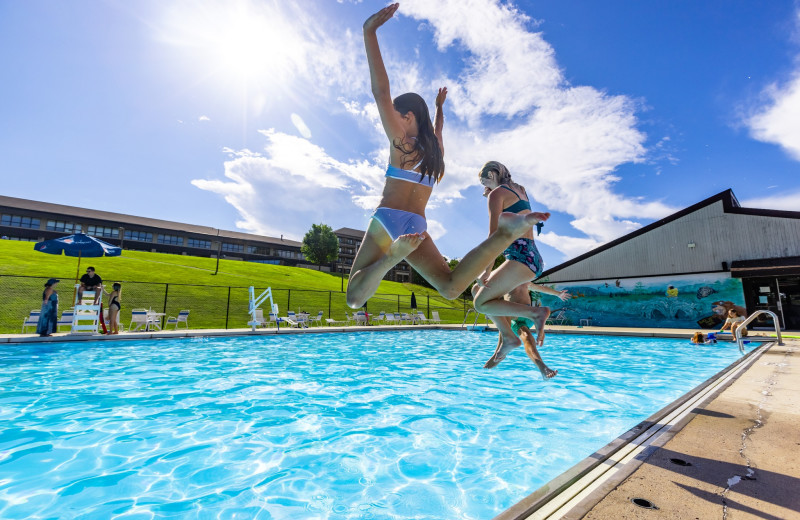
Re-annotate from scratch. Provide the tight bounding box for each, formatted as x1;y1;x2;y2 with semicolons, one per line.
347;4;541;309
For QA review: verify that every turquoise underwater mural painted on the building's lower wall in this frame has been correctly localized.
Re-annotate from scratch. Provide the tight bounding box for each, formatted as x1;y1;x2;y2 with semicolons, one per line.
539;273;746;328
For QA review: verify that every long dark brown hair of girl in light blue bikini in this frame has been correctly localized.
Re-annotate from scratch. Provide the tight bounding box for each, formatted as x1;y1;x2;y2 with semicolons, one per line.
392;92;444;182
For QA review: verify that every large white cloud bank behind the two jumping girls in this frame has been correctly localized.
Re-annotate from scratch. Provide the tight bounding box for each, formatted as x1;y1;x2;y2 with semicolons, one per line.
177;0;674;257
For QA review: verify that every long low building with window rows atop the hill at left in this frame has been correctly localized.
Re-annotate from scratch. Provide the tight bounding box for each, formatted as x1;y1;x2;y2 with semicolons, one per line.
0;196;306;265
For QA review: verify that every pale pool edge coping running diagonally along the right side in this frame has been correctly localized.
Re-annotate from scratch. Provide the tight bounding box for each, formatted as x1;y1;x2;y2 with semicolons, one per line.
492;338;778;520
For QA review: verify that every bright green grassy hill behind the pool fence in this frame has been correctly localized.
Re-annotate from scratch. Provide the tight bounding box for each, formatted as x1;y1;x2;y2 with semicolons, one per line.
0;240;467;333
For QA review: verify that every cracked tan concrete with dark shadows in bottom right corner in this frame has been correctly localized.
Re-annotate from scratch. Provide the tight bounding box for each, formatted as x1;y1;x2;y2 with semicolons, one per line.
572;340;800;520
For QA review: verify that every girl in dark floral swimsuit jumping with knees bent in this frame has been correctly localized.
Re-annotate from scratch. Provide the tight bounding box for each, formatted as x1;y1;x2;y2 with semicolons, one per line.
473;161;550;368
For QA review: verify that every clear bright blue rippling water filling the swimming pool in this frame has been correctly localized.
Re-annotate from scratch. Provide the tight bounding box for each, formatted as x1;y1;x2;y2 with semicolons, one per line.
0;331;753;520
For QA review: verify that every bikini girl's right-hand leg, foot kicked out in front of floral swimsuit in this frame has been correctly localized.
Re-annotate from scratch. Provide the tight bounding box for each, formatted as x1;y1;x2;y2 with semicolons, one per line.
406;213;542;300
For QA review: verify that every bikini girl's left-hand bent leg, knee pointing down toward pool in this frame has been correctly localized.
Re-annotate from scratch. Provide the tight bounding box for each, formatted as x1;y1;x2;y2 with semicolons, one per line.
347;219;425;309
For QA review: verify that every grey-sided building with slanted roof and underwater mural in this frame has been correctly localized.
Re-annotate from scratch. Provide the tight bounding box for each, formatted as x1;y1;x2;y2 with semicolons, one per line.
538;190;800;330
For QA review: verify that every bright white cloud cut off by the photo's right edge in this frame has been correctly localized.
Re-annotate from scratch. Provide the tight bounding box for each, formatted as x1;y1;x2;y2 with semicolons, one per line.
746;9;800;161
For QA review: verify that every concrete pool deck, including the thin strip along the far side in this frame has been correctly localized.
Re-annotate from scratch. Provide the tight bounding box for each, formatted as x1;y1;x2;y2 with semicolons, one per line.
0;325;800;520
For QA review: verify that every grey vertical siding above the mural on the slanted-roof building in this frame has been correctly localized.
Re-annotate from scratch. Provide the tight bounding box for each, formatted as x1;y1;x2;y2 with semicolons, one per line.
549;201;800;281
